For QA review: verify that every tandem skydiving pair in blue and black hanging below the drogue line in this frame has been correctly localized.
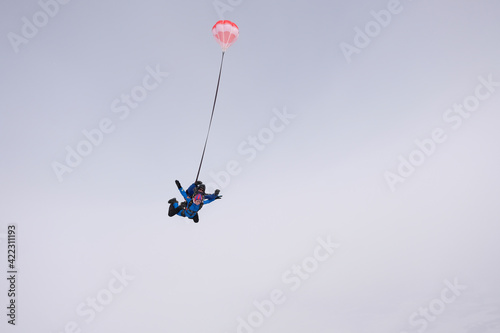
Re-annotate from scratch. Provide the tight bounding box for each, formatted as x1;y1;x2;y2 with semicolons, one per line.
168;180;222;223
